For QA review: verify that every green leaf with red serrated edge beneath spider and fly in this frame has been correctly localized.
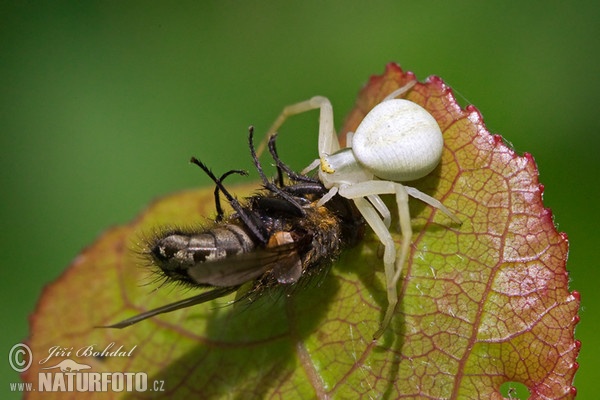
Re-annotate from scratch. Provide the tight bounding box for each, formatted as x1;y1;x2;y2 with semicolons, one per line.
23;64;580;399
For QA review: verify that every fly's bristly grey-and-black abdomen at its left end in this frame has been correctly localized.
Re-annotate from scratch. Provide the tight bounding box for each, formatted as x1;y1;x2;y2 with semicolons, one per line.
150;224;255;284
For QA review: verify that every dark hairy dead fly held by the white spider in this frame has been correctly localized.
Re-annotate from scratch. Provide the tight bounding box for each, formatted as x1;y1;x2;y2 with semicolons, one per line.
108;127;365;328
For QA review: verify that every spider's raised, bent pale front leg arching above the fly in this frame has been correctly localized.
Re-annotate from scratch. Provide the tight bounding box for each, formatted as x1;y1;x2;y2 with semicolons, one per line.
256;96;340;161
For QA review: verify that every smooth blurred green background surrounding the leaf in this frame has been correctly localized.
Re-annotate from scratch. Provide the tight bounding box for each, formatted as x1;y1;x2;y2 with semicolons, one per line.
0;0;600;399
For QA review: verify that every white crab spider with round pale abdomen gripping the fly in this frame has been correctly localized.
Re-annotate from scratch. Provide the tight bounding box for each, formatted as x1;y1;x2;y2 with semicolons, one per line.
259;81;460;338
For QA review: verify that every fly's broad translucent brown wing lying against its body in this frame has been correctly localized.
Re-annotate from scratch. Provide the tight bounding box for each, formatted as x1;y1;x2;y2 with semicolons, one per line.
188;242;302;287
